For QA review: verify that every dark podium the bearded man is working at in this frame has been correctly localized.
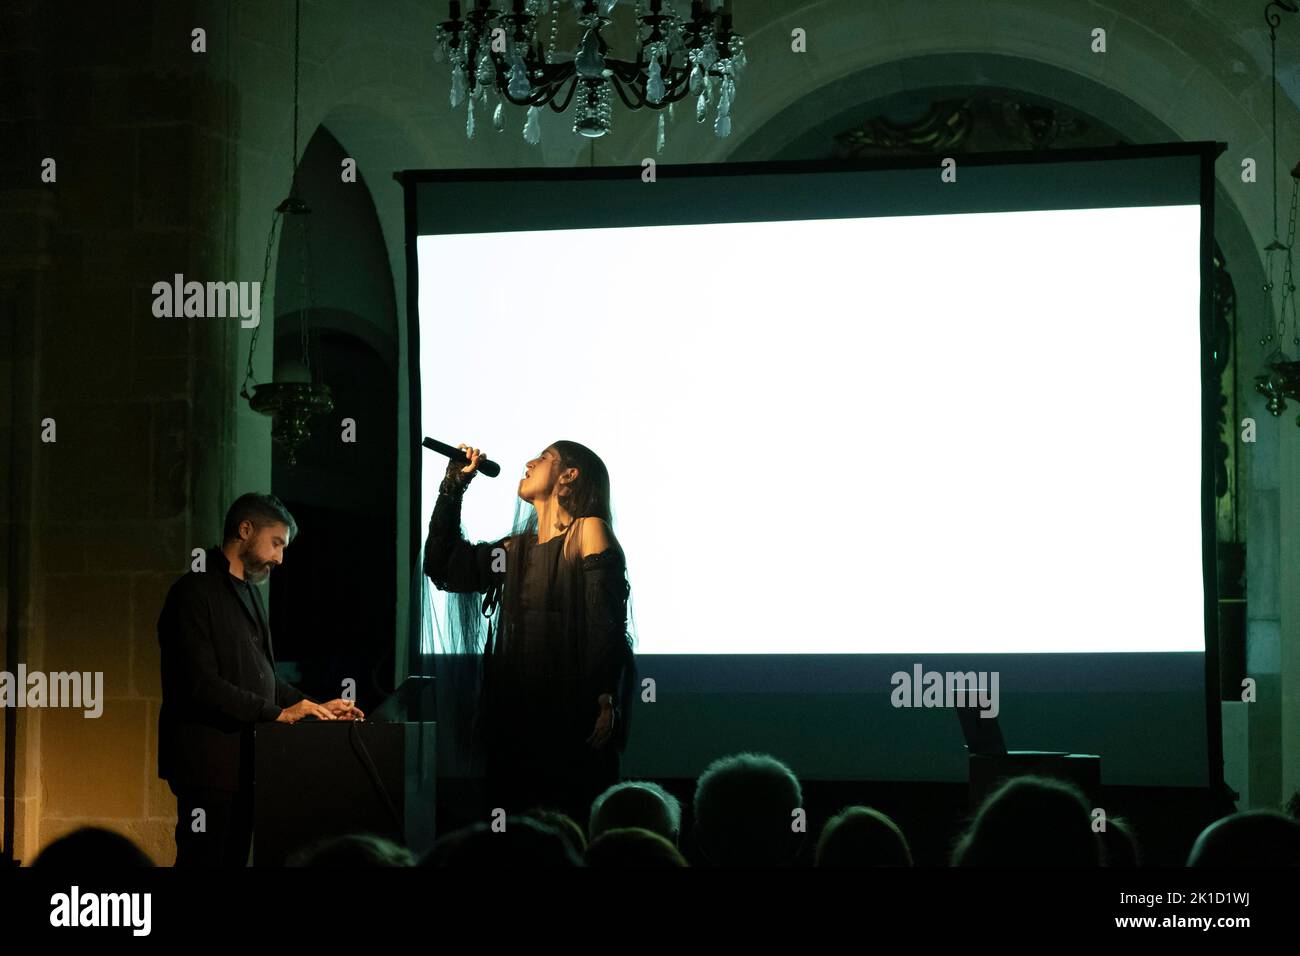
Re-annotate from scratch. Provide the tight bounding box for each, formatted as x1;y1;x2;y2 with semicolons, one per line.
252;721;438;866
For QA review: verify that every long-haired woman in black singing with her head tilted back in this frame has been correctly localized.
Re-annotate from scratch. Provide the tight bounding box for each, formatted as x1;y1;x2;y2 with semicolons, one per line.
424;441;636;823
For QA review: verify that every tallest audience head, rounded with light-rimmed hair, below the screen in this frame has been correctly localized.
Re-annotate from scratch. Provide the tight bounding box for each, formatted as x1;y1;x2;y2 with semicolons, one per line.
694;753;803;866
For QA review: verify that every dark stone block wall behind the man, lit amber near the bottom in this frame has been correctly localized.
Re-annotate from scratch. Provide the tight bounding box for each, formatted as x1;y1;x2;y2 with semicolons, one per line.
0;3;234;864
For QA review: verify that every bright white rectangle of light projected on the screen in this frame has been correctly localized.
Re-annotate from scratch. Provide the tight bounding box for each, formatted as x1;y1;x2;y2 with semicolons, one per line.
417;206;1204;654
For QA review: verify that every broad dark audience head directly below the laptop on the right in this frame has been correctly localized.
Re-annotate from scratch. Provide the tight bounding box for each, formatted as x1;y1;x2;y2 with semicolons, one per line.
953;777;1101;866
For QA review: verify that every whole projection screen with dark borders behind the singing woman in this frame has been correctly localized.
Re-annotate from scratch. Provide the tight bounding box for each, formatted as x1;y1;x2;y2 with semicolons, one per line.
400;144;1221;786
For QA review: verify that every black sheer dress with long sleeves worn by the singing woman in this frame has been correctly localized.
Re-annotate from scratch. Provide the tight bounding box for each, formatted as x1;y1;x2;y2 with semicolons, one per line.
424;479;636;826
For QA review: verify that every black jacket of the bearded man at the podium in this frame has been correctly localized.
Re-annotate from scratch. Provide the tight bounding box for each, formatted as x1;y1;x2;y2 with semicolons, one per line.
159;548;306;791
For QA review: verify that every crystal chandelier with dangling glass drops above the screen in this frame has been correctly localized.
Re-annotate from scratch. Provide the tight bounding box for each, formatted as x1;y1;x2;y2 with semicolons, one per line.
436;0;745;151
